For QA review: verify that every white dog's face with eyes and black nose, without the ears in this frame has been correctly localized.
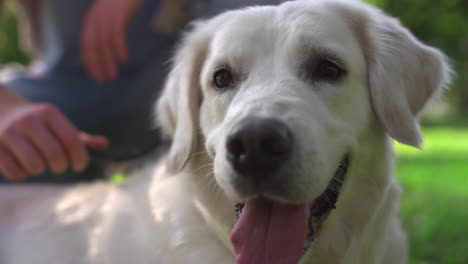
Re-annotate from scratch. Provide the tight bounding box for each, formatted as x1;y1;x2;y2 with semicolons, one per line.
200;5;372;203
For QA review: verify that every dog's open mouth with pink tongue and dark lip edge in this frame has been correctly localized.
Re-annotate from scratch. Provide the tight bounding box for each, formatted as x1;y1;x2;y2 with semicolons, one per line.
231;155;350;264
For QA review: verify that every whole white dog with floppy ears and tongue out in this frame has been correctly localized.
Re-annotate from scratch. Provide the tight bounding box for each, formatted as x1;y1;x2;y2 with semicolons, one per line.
0;0;450;264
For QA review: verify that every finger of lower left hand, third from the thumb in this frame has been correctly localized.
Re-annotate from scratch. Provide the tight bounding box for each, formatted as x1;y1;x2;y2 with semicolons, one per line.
2;127;46;175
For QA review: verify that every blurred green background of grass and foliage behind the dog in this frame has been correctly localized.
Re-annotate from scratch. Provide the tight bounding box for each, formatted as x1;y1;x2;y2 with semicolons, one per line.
0;0;468;264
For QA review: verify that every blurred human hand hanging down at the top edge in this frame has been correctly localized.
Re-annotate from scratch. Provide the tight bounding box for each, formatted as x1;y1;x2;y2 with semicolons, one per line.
80;0;143;82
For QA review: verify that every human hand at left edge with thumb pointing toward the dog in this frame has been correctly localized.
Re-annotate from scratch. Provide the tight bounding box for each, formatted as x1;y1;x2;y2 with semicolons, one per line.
0;102;108;181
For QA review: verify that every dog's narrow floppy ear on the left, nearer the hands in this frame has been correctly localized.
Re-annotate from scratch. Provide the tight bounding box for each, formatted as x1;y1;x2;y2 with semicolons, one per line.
156;22;211;172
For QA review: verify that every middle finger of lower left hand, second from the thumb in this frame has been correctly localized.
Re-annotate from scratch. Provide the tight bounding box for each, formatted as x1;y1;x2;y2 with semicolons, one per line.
25;119;68;174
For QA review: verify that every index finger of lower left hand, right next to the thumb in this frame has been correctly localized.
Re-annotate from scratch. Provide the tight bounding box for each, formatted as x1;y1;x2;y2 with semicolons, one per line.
42;105;89;172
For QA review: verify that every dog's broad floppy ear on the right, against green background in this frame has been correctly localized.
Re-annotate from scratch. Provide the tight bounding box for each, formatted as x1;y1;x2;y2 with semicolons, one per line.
338;4;452;147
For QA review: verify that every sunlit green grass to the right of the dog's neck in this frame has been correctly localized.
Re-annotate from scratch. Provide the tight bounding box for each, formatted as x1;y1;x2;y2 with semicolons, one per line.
396;127;468;264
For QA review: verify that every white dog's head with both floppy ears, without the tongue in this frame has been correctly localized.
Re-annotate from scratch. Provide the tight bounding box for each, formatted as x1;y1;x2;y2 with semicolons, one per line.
157;0;450;262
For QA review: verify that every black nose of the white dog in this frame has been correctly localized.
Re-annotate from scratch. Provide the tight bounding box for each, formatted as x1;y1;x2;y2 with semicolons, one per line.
226;118;293;175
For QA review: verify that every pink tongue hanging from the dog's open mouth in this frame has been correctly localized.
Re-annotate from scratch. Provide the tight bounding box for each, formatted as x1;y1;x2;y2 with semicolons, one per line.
231;198;309;264
